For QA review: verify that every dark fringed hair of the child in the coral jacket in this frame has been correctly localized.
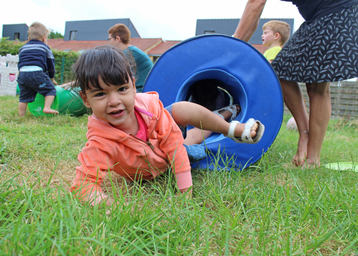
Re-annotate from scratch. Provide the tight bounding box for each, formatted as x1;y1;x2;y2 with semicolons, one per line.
72;45;133;92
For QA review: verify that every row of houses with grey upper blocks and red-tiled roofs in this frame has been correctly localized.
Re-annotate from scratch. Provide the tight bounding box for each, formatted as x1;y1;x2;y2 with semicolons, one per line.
3;18;294;58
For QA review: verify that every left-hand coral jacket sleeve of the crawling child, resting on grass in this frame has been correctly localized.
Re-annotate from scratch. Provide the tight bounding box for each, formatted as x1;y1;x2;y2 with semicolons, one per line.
71;140;114;198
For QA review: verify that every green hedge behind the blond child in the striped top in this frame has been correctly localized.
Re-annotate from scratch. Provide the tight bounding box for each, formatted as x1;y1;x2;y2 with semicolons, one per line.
0;38;80;84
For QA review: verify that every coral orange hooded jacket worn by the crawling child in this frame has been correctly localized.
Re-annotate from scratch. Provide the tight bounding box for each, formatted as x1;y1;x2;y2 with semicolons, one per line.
71;92;192;195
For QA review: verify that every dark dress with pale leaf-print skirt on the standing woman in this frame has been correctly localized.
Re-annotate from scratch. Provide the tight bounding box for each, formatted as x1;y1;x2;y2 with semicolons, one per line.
272;0;358;83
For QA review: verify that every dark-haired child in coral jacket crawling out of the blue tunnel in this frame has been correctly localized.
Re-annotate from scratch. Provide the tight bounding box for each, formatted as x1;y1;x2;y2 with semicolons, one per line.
71;45;264;205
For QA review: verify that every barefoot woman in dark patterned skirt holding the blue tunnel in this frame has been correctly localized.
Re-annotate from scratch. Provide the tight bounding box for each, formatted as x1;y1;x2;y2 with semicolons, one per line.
234;0;358;168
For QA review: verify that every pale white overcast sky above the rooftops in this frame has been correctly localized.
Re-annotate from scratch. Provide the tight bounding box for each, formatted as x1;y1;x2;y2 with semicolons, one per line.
0;0;303;40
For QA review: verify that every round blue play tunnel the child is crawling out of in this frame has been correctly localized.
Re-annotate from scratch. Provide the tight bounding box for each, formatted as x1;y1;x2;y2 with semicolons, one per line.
144;35;283;169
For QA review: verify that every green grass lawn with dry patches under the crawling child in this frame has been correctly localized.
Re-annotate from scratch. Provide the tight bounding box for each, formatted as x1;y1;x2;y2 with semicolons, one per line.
0;97;358;255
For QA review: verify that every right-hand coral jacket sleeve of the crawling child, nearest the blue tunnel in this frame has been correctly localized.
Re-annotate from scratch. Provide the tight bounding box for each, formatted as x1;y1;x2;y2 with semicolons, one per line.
157;101;191;178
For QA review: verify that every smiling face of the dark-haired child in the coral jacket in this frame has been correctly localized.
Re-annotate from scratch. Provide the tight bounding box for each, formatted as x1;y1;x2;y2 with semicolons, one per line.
80;78;136;132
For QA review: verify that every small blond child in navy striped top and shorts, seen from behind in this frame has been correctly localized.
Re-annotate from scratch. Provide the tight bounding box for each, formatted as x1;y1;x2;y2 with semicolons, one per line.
17;22;58;116
